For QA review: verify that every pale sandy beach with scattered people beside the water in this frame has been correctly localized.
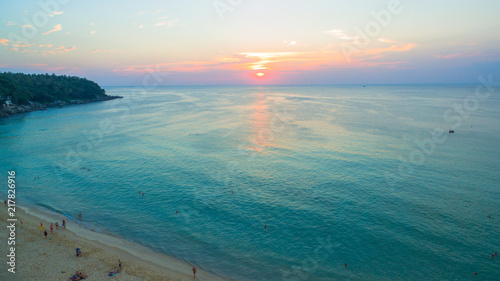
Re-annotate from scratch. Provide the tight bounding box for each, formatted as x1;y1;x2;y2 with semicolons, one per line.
0;204;226;281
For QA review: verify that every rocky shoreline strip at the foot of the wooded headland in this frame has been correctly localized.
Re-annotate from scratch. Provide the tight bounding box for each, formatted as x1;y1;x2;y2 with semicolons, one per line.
0;96;123;120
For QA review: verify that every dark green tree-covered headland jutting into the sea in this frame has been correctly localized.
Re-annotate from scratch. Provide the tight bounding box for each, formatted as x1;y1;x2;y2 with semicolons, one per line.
0;72;122;118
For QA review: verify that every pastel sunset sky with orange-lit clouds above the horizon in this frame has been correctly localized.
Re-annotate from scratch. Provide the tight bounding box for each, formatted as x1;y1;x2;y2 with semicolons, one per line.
0;0;500;86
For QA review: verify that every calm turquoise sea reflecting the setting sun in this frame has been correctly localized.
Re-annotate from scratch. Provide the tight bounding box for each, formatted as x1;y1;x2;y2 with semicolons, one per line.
0;85;500;280
